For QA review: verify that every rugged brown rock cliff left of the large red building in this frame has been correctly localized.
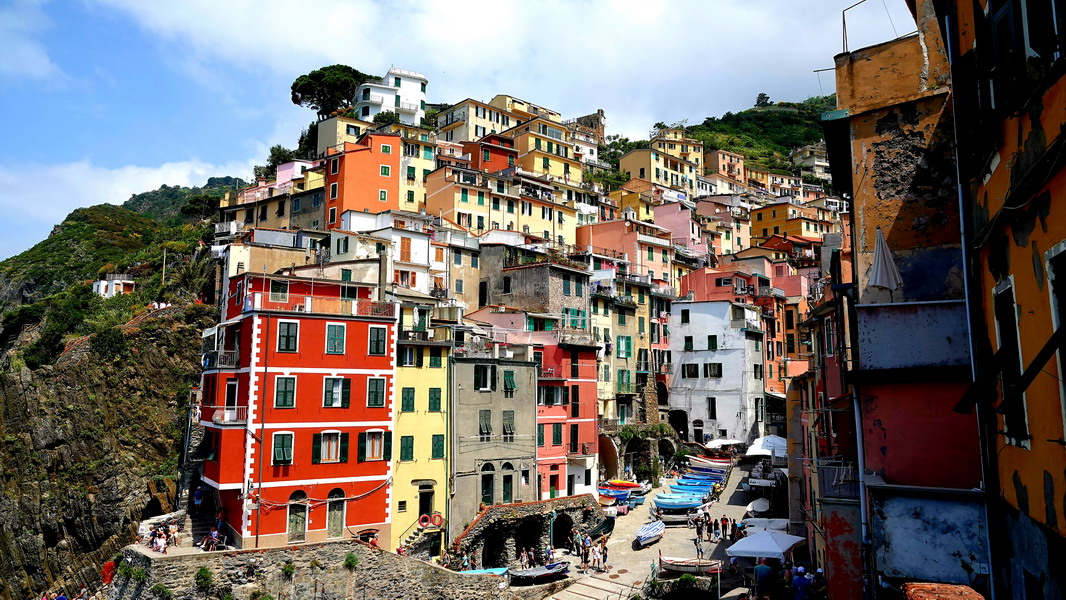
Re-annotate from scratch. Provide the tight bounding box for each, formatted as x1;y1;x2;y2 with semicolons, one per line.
0;306;213;600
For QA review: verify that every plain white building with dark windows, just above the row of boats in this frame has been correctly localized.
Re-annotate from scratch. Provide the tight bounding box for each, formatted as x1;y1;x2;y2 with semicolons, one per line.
669;299;764;442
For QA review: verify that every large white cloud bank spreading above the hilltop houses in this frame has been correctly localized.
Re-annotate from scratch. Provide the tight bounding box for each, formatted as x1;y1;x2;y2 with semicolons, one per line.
102;0;914;136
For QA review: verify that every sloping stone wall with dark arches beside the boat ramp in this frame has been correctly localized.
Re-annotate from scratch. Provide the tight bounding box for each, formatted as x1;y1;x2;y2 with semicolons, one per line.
451;493;604;568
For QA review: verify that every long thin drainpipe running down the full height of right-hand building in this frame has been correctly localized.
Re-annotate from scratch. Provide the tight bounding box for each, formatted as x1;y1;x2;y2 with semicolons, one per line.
943;14;1003;600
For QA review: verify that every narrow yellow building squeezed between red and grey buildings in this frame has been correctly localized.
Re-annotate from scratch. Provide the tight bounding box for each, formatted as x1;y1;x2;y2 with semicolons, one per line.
396;303;451;552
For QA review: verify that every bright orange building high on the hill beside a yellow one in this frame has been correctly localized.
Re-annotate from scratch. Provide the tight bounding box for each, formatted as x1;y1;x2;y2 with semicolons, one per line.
324;133;403;229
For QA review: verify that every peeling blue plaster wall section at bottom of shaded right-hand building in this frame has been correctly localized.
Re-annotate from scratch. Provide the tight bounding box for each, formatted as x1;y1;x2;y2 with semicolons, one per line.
870;489;988;585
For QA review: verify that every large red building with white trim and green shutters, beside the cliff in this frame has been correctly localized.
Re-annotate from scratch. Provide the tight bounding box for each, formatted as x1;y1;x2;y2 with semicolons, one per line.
200;274;397;548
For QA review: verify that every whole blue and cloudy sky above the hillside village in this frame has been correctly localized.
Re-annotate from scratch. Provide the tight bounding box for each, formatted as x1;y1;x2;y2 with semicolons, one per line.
0;0;915;258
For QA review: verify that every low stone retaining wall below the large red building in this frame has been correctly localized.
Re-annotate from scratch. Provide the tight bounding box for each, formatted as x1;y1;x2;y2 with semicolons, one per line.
108;540;502;600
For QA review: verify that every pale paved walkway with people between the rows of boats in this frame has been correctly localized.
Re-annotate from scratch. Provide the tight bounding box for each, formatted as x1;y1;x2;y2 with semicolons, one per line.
541;458;752;600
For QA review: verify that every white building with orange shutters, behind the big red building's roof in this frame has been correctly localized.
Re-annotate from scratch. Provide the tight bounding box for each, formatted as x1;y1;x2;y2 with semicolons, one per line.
340;210;433;297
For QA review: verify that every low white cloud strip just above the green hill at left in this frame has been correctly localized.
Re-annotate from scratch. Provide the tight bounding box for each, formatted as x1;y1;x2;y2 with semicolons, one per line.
0;159;253;257
